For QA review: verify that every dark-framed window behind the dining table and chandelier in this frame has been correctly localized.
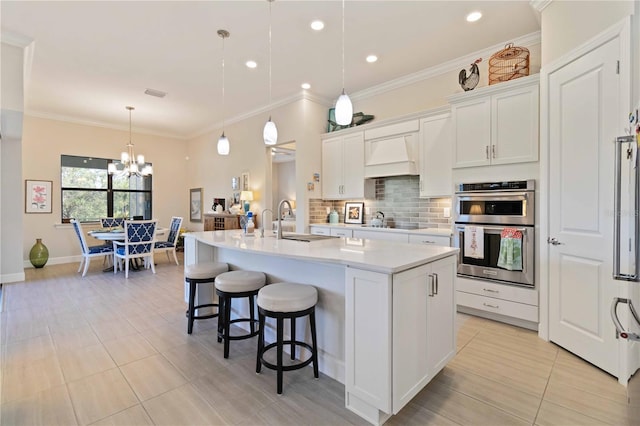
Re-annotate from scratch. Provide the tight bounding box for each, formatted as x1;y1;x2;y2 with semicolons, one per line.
60;155;152;222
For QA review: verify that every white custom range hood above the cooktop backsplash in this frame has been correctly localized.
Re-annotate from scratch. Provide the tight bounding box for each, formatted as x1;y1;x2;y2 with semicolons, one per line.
364;120;420;178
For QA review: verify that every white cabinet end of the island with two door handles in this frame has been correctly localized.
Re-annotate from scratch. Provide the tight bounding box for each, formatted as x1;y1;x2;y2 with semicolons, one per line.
345;255;456;424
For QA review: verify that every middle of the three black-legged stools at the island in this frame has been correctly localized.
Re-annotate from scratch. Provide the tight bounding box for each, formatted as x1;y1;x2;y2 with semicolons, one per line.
216;271;267;358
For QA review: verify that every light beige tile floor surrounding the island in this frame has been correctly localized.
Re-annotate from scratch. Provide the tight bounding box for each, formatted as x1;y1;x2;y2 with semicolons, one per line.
0;257;640;425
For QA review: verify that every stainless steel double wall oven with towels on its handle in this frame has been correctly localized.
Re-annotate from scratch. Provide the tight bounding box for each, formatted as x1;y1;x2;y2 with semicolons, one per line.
454;180;535;287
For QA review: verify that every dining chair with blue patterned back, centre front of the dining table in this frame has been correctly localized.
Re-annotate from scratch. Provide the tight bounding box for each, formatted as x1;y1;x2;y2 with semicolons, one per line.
113;220;158;278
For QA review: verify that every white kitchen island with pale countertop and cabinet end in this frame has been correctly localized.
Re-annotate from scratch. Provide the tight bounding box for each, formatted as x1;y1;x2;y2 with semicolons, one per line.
185;230;458;424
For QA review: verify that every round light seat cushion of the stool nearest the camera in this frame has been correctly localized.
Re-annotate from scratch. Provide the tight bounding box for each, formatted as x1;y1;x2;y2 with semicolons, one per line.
258;283;318;312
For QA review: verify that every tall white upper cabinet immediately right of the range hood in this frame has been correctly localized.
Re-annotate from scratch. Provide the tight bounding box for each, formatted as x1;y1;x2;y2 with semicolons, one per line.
420;113;453;197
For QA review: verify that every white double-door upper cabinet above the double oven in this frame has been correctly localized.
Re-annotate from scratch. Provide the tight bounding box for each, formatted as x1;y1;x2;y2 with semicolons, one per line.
448;75;539;168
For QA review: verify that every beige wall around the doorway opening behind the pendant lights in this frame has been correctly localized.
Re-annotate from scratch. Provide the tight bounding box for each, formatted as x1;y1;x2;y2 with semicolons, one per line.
184;95;329;231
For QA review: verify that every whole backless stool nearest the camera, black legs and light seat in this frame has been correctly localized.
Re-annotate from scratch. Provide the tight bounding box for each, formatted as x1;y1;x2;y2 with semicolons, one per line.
256;283;319;394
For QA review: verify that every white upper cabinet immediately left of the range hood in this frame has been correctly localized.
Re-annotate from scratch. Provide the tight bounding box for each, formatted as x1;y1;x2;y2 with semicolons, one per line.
322;132;365;200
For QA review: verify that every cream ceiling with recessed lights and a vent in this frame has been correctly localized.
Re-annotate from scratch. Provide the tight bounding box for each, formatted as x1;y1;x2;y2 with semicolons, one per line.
0;0;540;138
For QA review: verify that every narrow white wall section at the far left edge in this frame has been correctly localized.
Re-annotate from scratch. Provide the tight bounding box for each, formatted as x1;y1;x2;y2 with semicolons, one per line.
0;43;24;283
